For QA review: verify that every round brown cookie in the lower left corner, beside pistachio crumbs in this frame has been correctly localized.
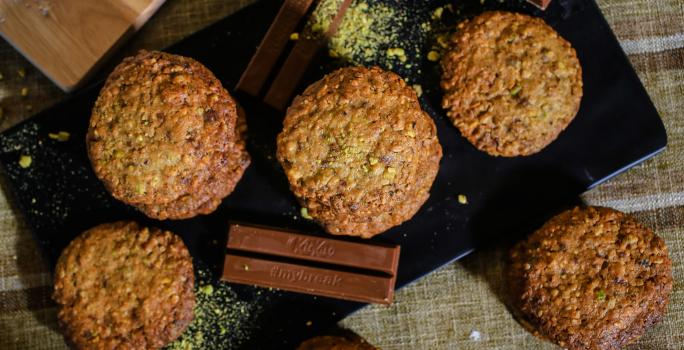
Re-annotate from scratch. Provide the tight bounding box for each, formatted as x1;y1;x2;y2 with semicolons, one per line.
53;221;195;349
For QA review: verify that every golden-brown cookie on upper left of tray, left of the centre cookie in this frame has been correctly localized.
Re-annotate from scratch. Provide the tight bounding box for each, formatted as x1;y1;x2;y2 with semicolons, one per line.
86;51;244;219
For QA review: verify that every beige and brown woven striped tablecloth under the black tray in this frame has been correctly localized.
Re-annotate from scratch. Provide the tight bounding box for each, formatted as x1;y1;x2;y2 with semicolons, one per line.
0;0;684;349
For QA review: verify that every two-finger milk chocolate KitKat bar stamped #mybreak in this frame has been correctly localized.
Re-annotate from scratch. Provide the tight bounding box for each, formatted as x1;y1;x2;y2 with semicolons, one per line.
222;224;400;304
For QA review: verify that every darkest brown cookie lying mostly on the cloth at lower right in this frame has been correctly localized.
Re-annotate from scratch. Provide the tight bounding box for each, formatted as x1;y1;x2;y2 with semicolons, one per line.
509;207;672;350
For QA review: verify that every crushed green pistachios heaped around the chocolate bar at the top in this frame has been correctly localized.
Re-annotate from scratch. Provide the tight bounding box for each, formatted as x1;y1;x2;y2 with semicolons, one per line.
304;0;470;89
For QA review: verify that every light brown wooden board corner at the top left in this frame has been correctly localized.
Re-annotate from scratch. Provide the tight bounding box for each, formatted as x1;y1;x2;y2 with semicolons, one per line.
0;0;164;91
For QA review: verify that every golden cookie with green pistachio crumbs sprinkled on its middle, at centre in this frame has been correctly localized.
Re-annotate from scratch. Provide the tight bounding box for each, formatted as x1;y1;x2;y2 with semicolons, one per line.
277;67;442;238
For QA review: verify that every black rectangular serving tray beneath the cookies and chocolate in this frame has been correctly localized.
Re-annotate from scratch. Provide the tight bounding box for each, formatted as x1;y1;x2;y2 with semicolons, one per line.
0;0;667;349
